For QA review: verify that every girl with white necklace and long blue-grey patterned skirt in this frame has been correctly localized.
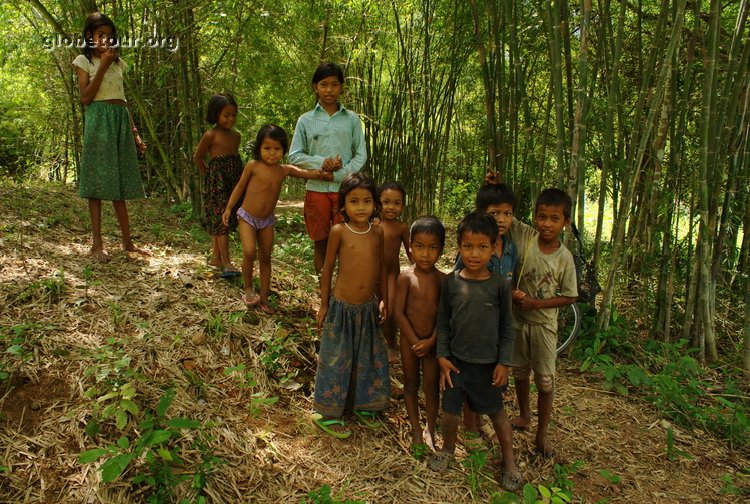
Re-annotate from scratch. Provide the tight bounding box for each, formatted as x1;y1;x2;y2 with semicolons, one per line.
313;173;391;439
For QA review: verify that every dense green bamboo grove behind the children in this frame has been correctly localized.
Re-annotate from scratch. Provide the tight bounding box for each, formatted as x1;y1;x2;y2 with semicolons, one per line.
0;0;750;369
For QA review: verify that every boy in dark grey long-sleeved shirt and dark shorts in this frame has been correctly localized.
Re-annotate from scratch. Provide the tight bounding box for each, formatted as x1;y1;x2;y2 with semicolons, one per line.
429;212;521;491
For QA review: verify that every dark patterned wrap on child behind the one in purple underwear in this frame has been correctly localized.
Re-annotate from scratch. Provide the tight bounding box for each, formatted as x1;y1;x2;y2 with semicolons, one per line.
203;154;244;236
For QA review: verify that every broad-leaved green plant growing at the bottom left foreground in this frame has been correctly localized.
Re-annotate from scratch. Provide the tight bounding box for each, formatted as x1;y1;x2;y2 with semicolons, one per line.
78;388;224;504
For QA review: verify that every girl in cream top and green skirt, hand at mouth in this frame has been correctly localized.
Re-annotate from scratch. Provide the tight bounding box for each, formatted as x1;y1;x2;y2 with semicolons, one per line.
73;12;149;262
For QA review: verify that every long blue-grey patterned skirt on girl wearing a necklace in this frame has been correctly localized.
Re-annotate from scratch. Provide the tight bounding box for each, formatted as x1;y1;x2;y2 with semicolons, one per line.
313;297;391;418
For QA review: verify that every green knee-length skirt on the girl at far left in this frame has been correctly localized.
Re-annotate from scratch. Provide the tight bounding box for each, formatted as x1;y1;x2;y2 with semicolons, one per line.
78;101;145;201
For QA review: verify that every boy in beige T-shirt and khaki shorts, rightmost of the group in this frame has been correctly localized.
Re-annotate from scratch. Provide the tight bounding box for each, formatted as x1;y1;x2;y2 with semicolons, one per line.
510;189;578;458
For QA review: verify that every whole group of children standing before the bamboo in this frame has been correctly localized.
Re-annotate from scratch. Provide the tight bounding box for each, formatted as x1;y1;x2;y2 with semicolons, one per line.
74;9;577;490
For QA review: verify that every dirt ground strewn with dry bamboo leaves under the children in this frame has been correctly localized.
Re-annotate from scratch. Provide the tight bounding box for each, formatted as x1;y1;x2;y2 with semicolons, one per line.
0;182;750;503
